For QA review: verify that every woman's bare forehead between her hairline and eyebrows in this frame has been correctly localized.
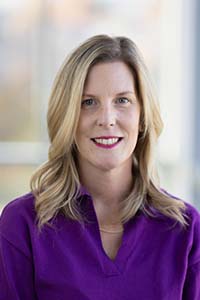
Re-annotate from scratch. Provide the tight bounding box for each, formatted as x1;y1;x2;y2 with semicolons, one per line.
84;61;135;94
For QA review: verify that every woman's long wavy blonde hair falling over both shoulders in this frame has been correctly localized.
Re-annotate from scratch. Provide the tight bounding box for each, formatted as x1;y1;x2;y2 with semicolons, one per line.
30;35;190;228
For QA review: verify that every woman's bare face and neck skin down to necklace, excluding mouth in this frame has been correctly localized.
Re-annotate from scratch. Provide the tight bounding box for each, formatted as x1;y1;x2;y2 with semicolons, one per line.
76;61;140;229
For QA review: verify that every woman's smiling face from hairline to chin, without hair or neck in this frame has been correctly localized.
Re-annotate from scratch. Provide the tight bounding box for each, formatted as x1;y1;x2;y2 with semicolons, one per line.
76;61;140;171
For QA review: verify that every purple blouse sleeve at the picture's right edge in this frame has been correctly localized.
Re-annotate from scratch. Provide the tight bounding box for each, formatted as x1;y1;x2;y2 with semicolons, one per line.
183;262;200;300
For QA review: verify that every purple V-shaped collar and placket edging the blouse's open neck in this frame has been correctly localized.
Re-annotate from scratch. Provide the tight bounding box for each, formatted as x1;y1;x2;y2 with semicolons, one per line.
81;192;141;276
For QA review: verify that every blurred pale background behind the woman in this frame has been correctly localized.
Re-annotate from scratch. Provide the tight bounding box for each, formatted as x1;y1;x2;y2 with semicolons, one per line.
0;0;200;211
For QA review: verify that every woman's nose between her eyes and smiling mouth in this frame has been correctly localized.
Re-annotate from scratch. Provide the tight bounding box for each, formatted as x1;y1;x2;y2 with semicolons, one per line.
96;105;116;127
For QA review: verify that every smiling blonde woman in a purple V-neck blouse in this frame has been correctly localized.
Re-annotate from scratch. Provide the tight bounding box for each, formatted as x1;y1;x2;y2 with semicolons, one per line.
0;35;200;300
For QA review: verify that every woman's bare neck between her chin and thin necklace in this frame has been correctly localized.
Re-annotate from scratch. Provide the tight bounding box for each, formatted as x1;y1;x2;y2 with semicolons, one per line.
79;159;133;225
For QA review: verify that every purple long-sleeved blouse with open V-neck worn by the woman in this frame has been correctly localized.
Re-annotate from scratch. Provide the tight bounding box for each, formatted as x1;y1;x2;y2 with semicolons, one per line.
0;193;200;300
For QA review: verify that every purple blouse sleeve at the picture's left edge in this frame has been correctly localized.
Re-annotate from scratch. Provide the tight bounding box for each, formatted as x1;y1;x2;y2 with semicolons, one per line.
0;235;37;300
